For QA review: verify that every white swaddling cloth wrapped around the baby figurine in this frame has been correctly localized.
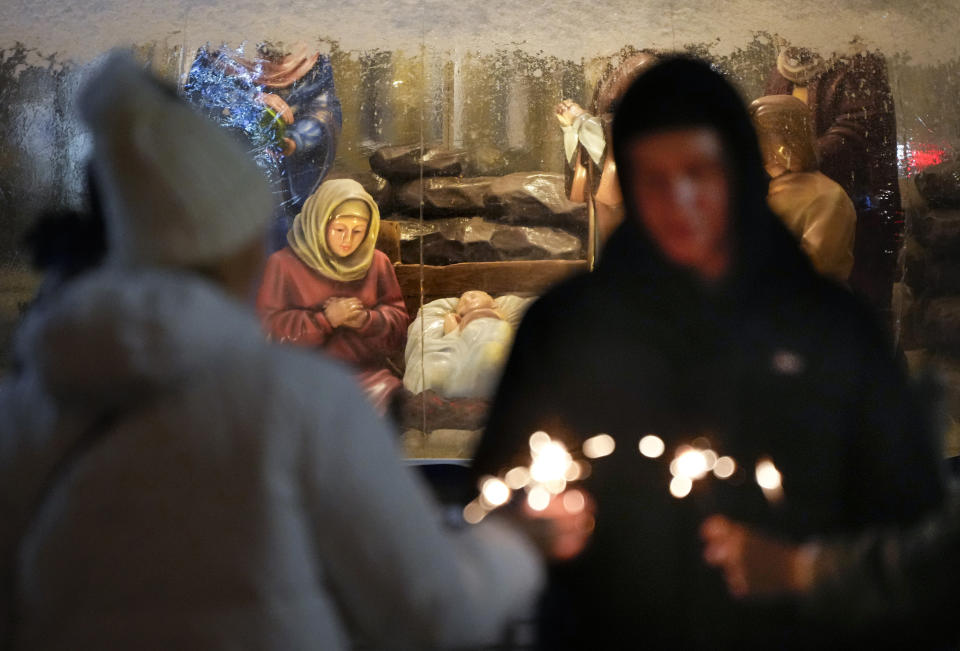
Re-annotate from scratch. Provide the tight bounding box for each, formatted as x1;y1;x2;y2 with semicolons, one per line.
403;295;535;399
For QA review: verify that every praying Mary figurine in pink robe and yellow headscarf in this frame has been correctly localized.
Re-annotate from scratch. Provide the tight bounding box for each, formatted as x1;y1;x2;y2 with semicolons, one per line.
257;179;410;412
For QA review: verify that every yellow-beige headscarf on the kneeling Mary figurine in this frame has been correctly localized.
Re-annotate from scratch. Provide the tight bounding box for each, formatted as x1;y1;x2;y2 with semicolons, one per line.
287;179;380;282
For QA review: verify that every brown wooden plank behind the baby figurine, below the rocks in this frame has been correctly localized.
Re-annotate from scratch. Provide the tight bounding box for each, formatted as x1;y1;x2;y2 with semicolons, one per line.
394;260;587;315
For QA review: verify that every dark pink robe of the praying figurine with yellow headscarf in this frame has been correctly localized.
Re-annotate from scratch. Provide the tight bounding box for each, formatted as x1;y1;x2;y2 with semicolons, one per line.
257;246;410;412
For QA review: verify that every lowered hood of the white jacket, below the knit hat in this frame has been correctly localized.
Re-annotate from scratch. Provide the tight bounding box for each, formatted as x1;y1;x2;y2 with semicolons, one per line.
14;269;265;408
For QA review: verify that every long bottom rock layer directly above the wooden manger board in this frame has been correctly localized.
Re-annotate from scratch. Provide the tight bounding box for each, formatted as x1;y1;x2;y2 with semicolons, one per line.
392;217;583;265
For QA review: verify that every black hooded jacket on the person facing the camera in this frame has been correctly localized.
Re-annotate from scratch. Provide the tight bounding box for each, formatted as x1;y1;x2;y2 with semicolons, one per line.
474;59;941;649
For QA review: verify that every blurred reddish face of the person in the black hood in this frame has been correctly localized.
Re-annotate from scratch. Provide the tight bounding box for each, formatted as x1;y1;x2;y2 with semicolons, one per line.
624;127;730;279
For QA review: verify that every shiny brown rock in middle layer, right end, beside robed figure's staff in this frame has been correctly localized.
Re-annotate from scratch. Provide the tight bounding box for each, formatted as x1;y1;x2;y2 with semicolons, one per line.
486;172;587;233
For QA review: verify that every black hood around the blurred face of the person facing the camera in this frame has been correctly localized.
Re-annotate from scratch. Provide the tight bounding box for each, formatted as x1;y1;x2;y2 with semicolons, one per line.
599;57;810;300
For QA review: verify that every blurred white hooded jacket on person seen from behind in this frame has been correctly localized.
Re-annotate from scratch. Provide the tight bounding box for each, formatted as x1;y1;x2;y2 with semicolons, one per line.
0;270;543;650
